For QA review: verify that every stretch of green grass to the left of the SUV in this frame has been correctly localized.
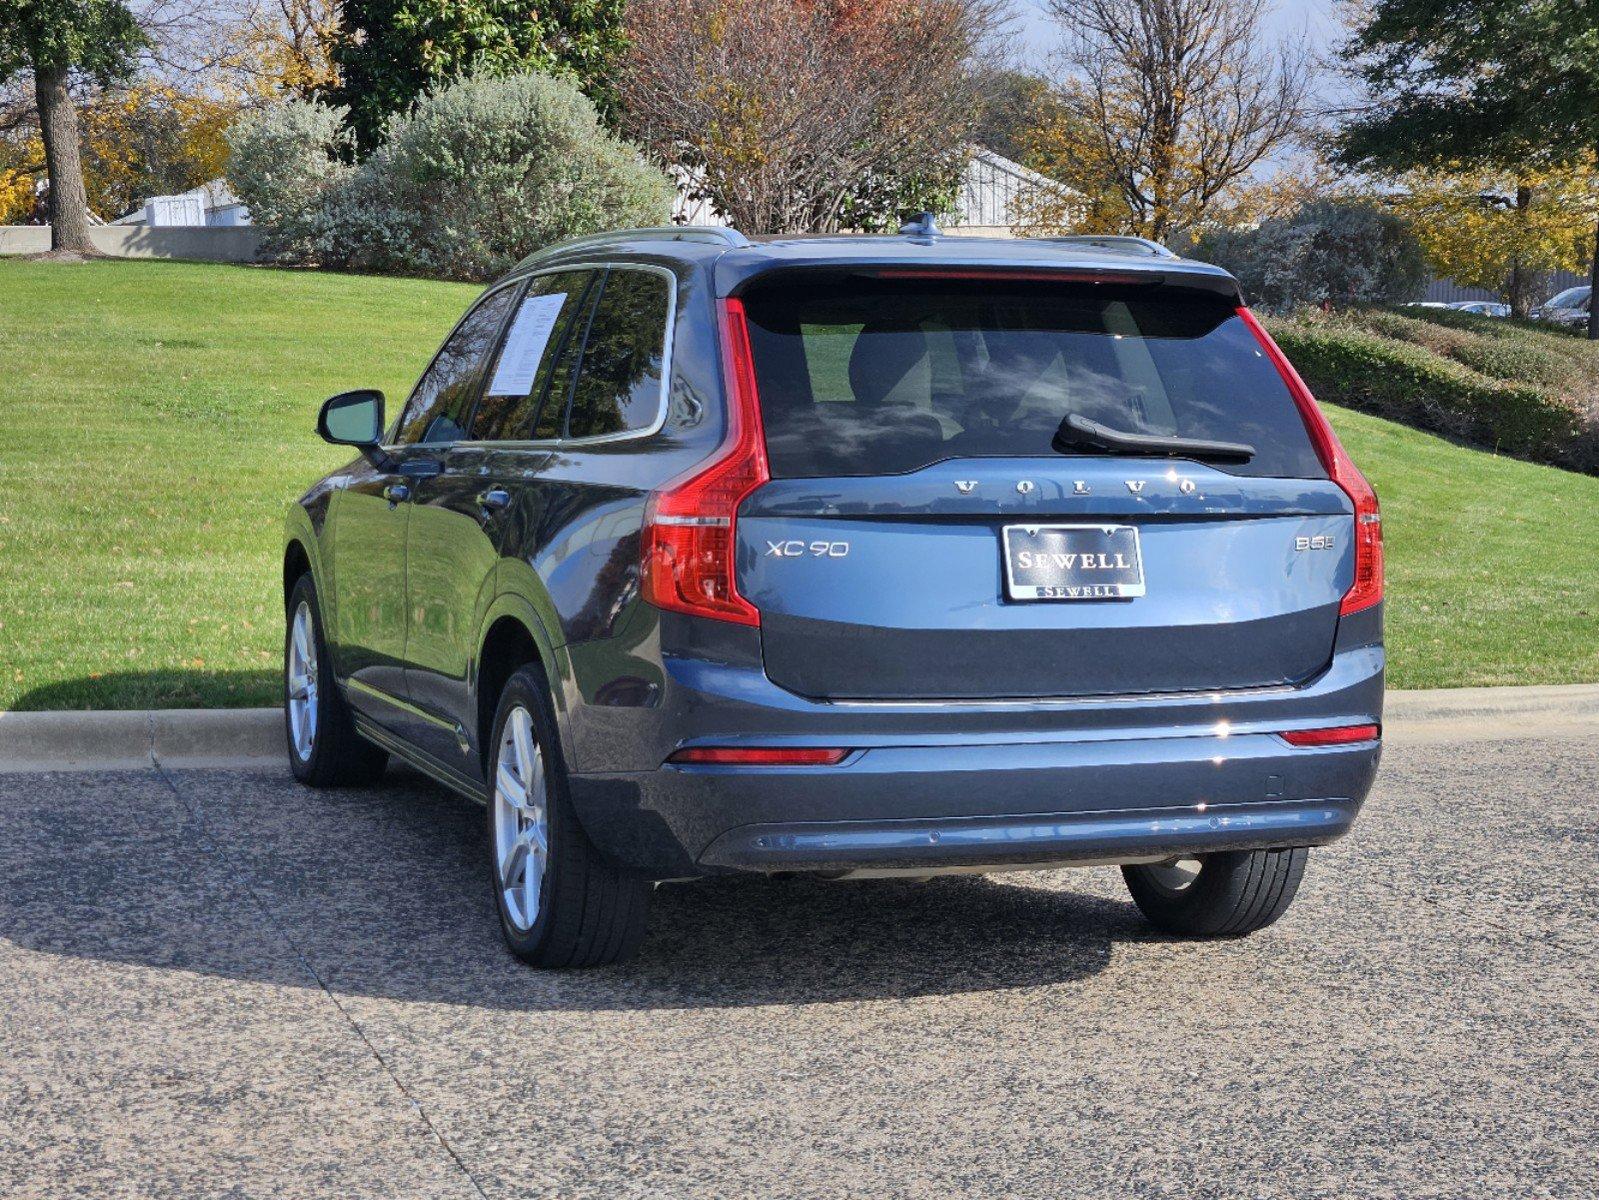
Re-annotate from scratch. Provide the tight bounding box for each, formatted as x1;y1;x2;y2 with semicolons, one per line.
0;259;477;709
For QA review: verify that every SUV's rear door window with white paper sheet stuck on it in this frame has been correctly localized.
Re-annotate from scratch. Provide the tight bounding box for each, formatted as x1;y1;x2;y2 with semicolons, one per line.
472;270;593;442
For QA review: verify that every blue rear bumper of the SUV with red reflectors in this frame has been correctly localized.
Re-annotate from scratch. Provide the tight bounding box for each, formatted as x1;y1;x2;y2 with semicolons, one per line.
571;733;1380;878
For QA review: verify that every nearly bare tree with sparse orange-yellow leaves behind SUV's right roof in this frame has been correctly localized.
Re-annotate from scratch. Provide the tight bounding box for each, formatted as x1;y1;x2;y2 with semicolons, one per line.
1047;0;1310;240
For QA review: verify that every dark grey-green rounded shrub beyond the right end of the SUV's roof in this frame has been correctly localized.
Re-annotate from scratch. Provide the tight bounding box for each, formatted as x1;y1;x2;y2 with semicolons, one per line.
1194;200;1426;312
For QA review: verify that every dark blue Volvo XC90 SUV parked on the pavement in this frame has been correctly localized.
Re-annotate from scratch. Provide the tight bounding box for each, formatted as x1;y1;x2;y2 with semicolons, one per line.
283;222;1383;966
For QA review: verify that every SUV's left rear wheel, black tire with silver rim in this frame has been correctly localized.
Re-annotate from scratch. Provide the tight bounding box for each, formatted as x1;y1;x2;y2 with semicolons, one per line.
488;666;651;966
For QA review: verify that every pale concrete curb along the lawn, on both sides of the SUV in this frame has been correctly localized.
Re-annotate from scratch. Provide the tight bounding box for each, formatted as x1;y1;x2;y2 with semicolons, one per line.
0;683;1599;774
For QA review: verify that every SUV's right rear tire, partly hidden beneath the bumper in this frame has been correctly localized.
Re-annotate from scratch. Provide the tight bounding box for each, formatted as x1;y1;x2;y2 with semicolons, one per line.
1121;846;1310;938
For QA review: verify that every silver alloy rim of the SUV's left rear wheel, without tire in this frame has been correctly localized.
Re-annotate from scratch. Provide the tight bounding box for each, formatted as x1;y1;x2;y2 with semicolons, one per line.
494;704;550;933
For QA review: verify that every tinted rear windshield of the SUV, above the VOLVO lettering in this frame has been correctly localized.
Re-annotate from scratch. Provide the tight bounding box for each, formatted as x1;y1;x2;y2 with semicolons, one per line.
745;277;1326;478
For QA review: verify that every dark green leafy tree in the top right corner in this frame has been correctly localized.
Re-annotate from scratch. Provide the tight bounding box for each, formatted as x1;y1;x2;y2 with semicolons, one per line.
1338;0;1599;339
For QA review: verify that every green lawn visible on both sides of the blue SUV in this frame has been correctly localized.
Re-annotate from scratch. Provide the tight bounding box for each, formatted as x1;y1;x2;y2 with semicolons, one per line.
0;261;1599;709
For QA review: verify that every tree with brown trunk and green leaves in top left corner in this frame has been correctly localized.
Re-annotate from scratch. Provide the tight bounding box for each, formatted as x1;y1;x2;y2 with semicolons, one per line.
0;0;146;254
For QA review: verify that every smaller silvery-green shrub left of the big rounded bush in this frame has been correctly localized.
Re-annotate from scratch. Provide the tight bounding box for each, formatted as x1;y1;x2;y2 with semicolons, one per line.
227;99;352;262
